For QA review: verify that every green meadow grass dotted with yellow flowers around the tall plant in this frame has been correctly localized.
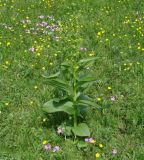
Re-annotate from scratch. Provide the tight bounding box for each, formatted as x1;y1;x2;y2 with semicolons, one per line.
0;0;144;160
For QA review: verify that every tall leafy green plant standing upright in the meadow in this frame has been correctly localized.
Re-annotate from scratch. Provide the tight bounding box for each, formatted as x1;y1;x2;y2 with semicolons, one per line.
43;57;97;136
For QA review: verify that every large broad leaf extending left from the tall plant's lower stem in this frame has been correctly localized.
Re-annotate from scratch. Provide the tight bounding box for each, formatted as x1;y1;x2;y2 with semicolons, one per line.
43;100;74;115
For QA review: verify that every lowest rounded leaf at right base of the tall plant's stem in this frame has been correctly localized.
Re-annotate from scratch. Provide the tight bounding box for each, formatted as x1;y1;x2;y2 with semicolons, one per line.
72;123;90;137
